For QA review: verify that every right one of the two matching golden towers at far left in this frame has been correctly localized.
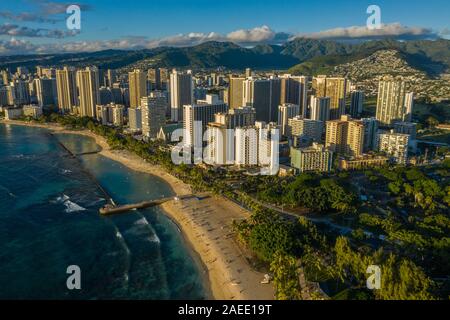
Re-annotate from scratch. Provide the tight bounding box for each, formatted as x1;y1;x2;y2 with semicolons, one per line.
76;67;100;118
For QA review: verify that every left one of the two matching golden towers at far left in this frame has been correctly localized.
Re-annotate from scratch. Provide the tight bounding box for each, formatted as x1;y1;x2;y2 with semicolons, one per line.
56;67;78;113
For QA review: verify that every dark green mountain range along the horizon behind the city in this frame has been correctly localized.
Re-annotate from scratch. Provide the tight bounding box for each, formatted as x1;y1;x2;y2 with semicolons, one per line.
0;38;450;77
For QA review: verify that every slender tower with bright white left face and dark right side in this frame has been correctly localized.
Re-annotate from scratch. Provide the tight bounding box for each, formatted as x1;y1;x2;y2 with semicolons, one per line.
170;69;194;122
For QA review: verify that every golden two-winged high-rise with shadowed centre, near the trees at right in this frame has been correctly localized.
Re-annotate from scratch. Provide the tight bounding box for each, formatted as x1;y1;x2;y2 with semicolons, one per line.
325;115;364;157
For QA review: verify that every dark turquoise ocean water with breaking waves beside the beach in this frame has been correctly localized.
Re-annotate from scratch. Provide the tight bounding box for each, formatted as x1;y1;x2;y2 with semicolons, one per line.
0;124;206;299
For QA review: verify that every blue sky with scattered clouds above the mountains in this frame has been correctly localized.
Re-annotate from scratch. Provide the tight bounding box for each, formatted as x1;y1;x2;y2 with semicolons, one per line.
0;0;450;55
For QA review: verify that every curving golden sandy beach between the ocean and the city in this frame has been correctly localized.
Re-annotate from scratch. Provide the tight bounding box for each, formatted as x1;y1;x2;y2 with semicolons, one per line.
0;120;274;300
